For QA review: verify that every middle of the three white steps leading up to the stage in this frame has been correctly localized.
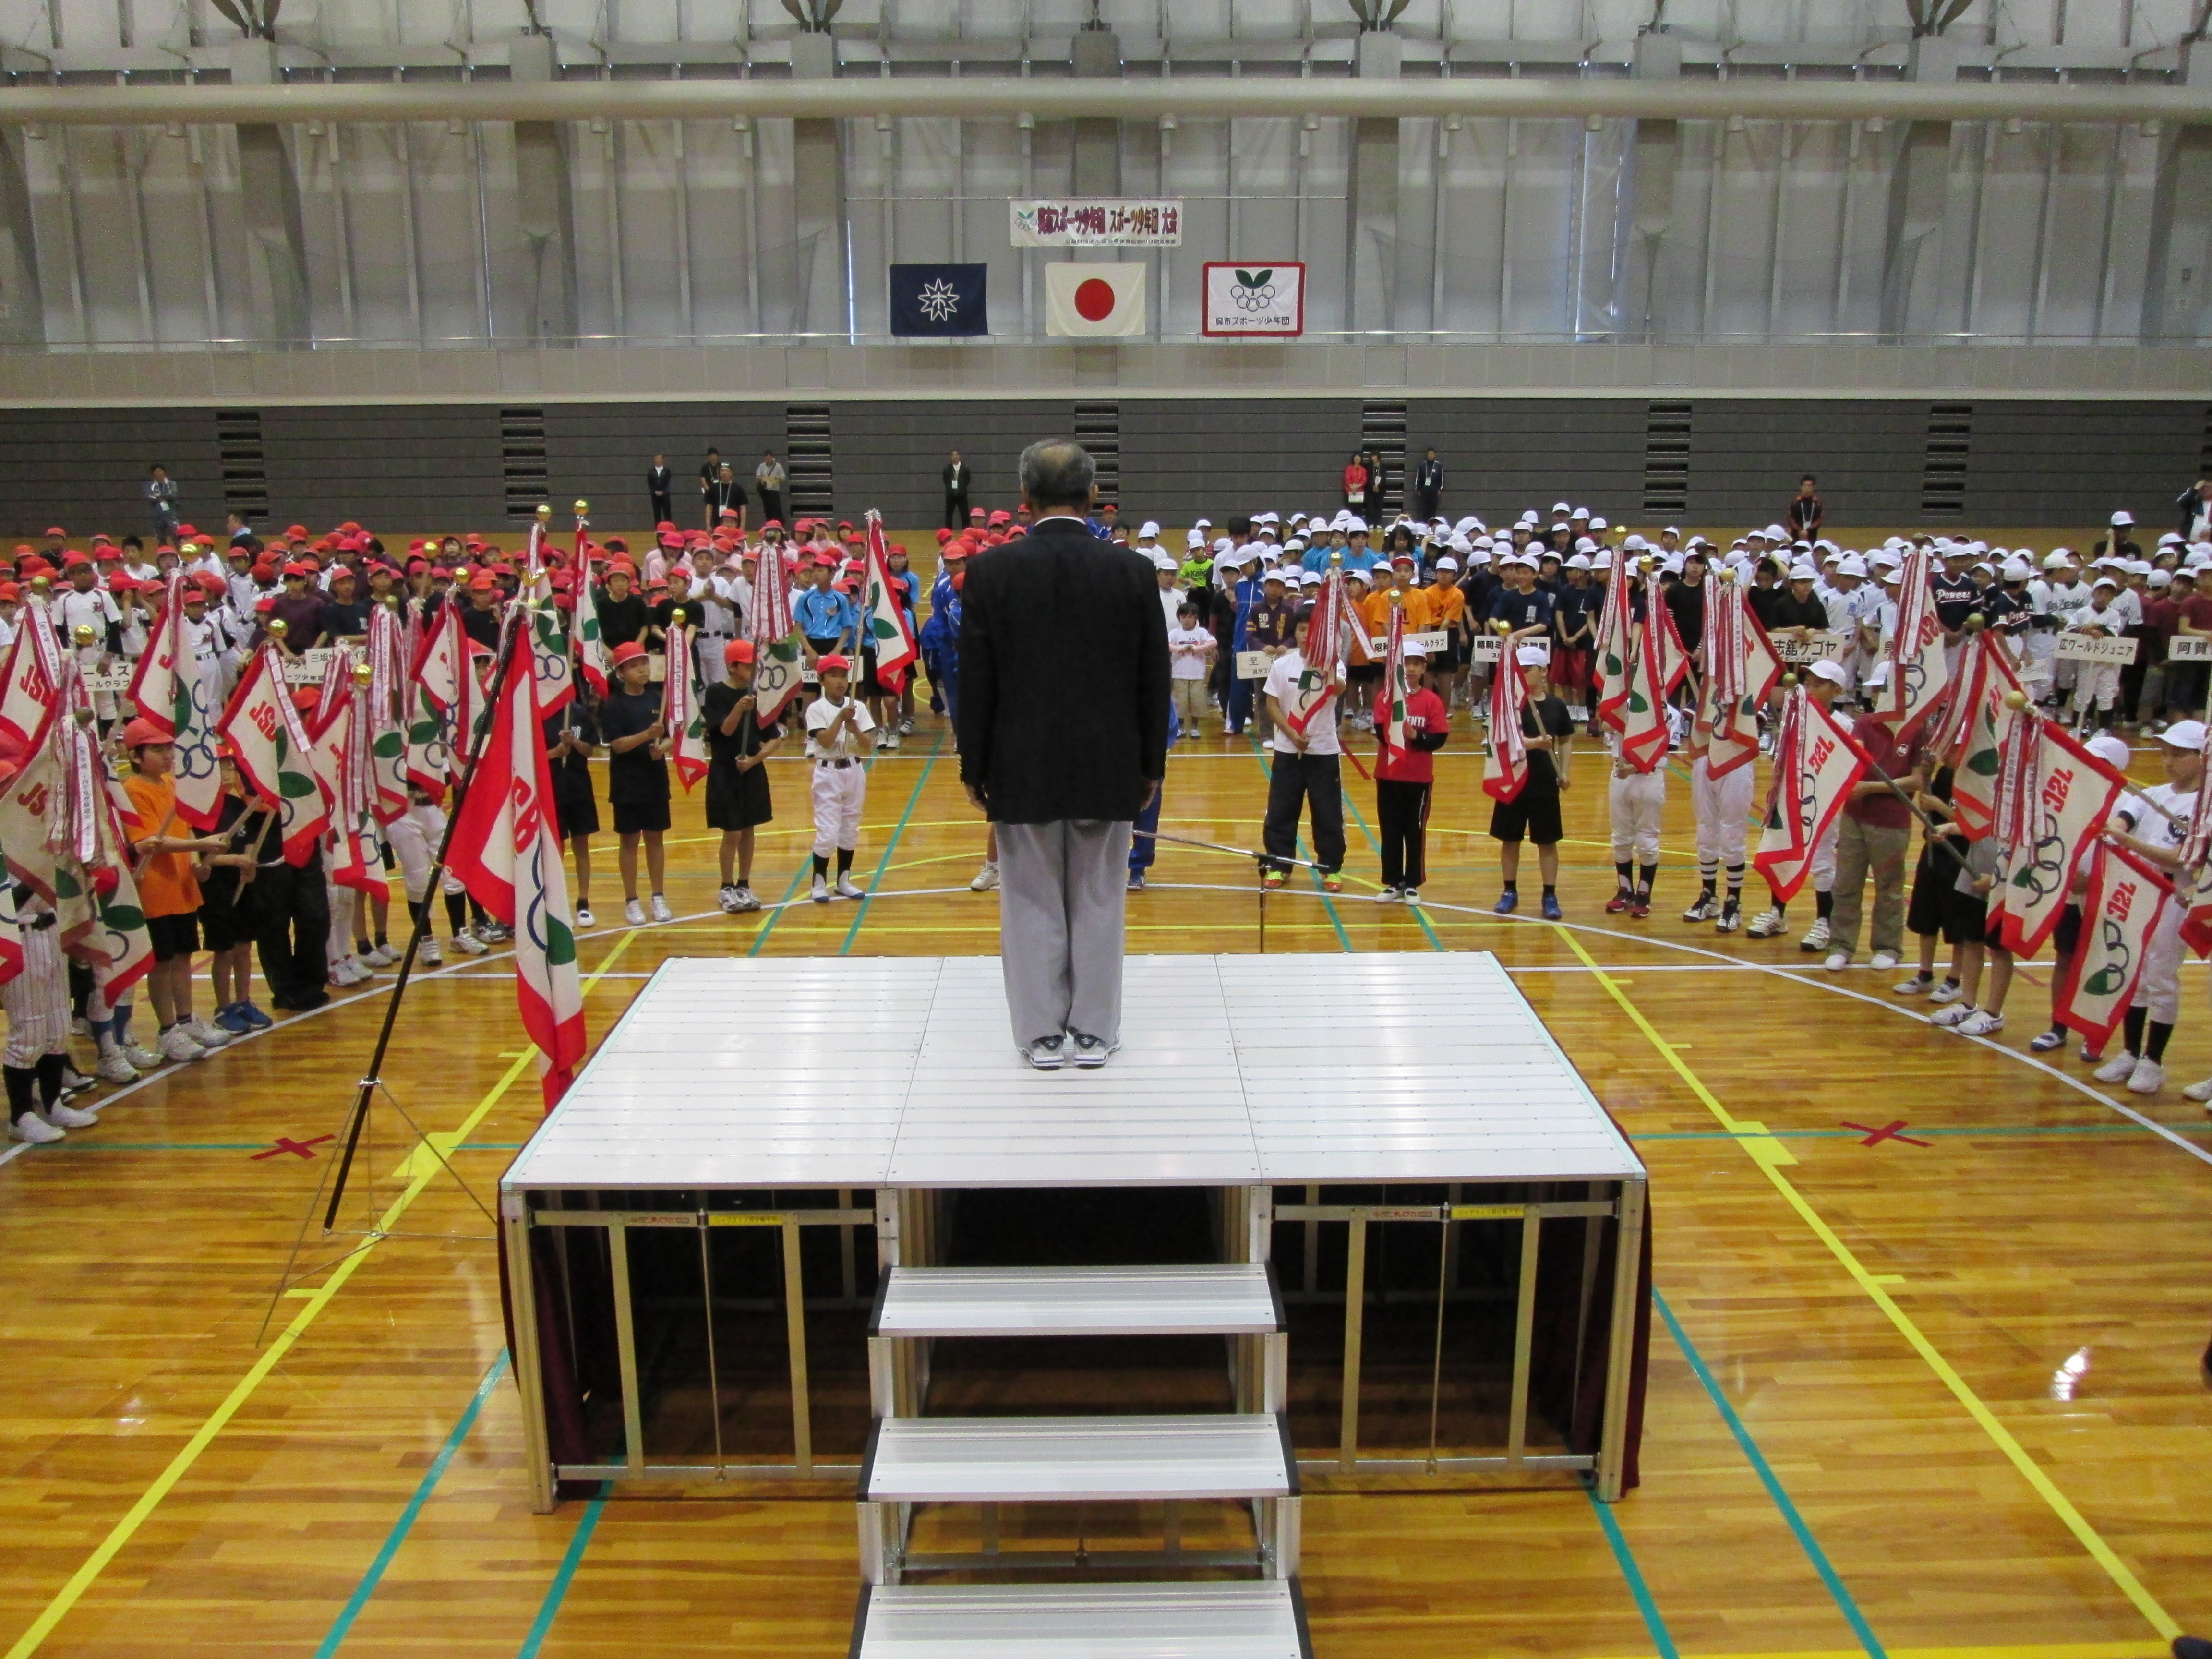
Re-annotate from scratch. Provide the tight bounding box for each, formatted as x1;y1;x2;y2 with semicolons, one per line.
861;1411;1298;1504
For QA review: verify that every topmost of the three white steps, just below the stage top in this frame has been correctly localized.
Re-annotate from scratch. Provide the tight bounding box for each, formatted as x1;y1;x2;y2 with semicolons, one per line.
869;1263;1283;1336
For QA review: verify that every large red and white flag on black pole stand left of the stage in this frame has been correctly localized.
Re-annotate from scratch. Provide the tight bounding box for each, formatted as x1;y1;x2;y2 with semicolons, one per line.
451;650;584;1110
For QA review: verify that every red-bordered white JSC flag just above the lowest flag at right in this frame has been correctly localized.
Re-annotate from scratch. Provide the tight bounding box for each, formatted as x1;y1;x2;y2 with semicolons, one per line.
1989;708;2126;956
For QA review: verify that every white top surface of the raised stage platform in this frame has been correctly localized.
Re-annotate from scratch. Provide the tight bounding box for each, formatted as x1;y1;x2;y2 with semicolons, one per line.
502;953;1644;1192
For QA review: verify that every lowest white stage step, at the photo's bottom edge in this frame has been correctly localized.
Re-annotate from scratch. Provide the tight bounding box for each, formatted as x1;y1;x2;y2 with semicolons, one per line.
852;1579;1312;1659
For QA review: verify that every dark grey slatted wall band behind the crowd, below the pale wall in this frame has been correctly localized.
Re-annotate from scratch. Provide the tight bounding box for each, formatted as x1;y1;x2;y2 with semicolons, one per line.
0;389;2208;540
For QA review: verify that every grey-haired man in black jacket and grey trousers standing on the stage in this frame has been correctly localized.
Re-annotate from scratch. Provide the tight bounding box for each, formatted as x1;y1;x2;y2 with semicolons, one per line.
958;438;1168;1070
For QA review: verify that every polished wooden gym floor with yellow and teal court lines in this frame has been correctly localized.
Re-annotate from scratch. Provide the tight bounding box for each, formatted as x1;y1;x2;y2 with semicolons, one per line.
0;717;2212;1659
